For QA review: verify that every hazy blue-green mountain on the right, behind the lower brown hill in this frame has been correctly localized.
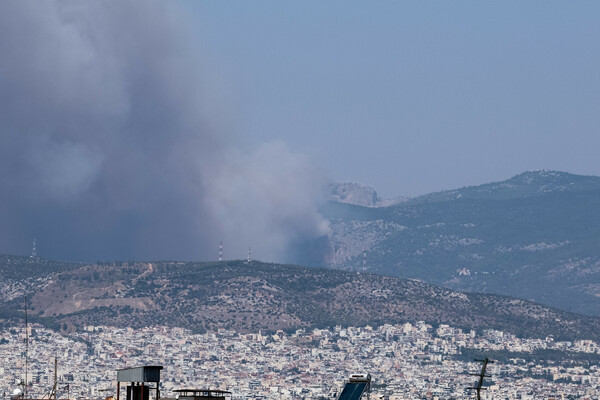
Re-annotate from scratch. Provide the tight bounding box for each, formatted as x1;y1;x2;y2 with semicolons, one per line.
322;171;600;315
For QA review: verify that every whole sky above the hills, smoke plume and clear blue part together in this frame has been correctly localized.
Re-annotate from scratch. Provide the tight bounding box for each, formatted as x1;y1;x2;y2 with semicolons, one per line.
0;0;600;261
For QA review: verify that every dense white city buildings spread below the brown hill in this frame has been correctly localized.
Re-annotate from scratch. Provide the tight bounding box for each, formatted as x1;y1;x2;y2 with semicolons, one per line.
0;322;600;400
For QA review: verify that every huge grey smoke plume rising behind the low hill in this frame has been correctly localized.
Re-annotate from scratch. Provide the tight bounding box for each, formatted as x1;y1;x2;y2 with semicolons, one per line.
0;1;328;261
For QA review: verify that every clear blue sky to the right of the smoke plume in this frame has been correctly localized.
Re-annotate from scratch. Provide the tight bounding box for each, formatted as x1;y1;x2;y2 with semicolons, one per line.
187;1;600;196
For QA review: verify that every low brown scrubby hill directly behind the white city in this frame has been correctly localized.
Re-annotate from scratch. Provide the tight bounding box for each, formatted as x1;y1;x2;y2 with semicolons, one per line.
0;259;600;340
